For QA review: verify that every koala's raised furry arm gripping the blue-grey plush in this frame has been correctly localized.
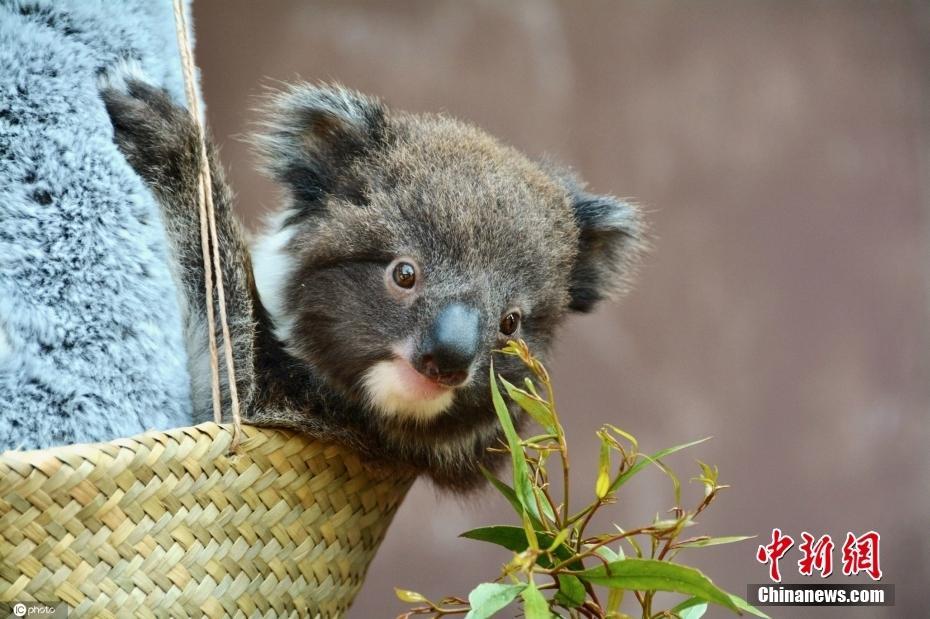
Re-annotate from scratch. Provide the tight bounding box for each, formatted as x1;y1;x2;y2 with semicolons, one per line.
101;78;257;421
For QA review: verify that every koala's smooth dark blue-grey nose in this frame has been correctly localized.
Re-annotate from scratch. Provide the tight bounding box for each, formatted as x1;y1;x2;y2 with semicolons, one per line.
417;303;480;387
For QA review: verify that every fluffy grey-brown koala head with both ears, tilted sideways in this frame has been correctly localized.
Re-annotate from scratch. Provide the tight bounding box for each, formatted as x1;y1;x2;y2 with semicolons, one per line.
246;84;642;490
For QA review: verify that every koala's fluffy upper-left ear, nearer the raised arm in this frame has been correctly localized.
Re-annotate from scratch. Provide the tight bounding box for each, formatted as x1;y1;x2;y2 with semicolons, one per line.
252;83;387;205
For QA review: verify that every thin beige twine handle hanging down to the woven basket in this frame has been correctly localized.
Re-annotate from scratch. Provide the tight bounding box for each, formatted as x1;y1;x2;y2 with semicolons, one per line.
174;0;242;450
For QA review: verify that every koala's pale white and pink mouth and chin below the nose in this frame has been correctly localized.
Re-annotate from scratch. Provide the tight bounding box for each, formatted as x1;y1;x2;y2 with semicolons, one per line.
362;356;458;420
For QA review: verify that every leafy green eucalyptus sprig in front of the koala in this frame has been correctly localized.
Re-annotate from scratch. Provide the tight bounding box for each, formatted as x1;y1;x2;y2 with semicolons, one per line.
396;341;767;619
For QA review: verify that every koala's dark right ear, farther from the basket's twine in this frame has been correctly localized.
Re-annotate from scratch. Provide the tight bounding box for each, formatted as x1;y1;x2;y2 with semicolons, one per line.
569;190;644;312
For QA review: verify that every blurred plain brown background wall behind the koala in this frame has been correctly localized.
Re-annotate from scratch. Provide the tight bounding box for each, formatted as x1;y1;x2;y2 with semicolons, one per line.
194;0;930;618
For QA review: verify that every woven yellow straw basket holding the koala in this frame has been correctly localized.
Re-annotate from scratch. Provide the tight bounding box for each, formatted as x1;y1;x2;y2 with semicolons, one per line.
0;423;412;617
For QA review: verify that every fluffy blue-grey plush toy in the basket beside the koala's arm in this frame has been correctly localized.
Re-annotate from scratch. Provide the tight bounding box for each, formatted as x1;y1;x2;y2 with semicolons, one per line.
0;0;191;450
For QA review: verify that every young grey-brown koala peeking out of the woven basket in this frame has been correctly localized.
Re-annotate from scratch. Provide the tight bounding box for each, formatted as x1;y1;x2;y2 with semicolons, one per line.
102;79;644;491
